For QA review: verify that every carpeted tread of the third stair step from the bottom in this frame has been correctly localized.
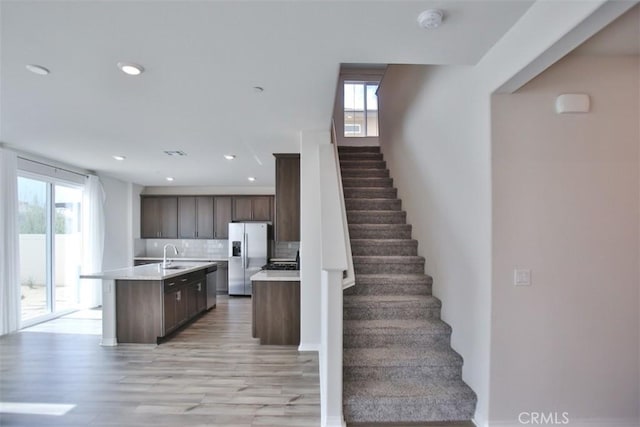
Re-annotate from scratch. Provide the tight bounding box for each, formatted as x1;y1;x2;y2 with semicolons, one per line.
344;318;451;335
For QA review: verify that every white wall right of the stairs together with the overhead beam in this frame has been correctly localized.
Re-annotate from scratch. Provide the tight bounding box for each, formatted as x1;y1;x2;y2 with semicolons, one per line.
379;0;631;426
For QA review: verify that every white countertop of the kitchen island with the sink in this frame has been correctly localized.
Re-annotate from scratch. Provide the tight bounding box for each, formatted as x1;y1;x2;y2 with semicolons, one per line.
80;261;216;280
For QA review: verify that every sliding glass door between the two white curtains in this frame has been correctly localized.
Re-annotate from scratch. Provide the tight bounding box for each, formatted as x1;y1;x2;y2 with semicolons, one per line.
18;176;82;325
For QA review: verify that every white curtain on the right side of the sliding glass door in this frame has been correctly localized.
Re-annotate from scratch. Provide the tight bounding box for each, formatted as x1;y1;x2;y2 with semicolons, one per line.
80;175;105;308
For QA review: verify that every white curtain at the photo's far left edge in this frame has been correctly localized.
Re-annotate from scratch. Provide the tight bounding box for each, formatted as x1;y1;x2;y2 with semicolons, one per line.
0;148;20;335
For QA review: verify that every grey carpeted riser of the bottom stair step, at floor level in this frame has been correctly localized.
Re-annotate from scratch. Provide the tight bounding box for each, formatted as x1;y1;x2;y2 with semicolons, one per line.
344;398;475;423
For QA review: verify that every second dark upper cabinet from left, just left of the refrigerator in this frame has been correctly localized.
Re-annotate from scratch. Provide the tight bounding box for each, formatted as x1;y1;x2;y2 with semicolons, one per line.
178;196;214;239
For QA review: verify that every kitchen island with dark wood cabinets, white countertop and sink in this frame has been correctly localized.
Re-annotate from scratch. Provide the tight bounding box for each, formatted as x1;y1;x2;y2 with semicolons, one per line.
81;262;217;345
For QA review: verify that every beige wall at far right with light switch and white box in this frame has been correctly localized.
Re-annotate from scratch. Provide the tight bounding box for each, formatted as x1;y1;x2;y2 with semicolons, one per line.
490;56;640;426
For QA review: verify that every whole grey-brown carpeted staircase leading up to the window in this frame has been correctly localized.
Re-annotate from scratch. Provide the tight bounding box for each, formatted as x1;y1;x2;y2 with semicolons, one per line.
338;147;476;423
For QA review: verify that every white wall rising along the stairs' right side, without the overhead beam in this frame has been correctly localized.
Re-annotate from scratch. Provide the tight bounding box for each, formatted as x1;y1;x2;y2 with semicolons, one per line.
380;66;491;420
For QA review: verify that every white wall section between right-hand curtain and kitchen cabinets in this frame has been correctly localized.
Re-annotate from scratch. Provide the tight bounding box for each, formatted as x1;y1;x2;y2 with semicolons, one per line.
100;175;141;270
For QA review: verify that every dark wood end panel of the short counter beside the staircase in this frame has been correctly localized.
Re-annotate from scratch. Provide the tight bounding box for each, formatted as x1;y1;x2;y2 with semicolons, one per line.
251;280;300;345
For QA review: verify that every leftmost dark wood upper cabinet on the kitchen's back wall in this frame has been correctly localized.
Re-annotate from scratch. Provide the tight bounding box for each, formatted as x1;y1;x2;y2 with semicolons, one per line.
140;196;178;239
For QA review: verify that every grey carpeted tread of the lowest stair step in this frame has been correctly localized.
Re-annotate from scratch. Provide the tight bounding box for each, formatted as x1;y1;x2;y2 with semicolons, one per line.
343;380;476;402
